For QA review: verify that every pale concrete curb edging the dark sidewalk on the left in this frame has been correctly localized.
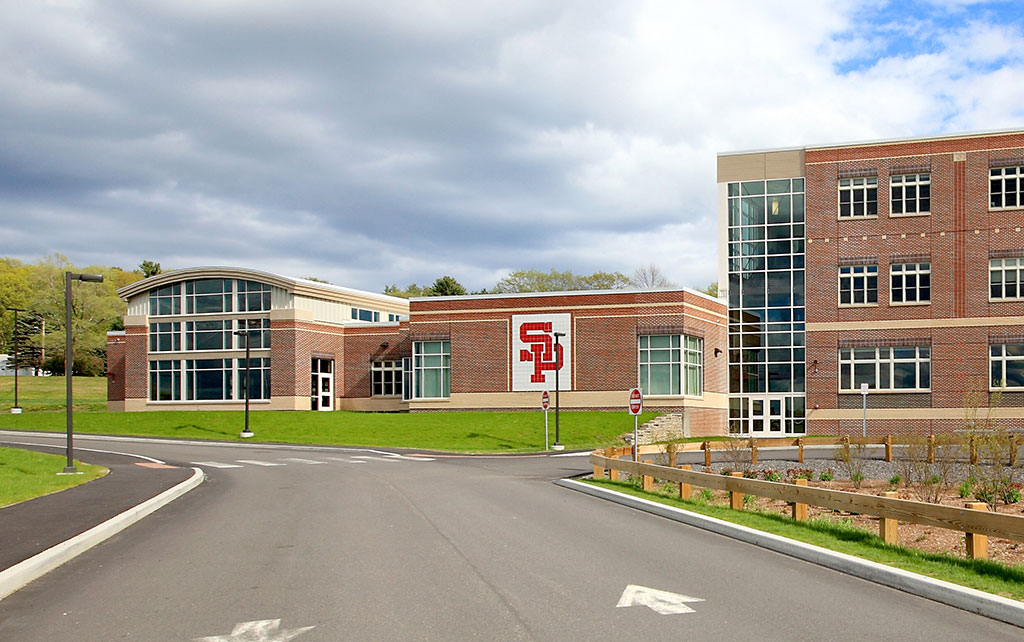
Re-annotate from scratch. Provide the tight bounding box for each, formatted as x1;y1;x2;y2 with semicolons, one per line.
0;468;206;600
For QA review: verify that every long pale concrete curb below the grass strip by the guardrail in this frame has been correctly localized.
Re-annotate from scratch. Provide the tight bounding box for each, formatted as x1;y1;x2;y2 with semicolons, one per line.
555;479;1024;627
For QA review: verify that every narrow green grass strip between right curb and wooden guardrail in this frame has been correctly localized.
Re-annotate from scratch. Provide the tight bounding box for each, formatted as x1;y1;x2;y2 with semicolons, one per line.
583;479;1024;600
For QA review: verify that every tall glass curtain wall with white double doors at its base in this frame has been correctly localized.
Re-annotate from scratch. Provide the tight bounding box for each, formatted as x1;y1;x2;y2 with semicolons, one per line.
728;178;806;435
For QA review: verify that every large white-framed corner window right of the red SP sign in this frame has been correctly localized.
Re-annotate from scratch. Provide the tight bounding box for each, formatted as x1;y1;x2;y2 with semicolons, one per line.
638;335;703;396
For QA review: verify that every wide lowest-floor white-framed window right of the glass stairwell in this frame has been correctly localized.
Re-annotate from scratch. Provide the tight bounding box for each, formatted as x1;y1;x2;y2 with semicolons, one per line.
839;346;932;392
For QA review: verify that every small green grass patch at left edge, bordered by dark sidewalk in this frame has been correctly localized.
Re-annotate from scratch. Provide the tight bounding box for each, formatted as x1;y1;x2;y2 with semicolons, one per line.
0;447;106;507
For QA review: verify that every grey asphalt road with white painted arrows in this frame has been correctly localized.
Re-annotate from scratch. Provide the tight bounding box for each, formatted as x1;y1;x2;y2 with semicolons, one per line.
0;436;1022;642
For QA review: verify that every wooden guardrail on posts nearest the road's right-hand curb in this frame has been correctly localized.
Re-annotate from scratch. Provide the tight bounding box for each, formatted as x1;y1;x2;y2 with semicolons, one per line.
590;448;1024;557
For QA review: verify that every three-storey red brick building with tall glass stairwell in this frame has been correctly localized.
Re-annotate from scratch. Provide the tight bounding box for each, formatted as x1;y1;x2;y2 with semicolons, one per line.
718;131;1024;435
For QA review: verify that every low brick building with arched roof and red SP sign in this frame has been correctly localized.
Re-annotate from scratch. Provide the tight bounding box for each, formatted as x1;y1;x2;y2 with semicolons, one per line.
108;267;728;435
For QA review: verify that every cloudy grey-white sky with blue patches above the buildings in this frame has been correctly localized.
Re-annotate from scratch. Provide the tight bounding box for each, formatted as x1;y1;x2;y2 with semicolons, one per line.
0;0;1024;292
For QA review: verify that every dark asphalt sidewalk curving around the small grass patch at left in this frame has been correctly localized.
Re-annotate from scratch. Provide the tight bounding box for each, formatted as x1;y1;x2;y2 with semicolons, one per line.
0;439;195;581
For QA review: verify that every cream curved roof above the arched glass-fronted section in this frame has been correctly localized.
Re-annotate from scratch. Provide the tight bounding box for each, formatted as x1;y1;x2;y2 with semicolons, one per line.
118;266;409;305
